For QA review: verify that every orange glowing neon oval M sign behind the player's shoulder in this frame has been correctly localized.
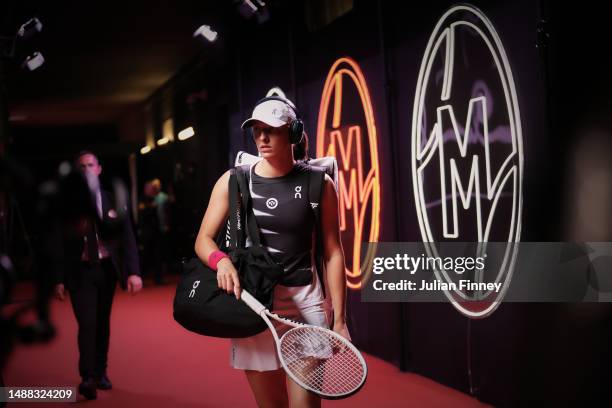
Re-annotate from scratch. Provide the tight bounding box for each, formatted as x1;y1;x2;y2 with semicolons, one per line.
317;58;381;289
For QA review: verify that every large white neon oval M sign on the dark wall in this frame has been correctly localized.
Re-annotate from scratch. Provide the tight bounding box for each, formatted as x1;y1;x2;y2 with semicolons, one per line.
411;5;523;317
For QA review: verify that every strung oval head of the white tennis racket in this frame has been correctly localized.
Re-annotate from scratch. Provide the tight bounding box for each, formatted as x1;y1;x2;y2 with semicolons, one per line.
281;327;365;395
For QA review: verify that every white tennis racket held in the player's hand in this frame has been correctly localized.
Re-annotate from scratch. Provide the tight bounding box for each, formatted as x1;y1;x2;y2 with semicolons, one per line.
240;289;368;399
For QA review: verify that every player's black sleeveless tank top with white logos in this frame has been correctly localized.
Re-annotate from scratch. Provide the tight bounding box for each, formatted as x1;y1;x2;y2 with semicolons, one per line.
247;162;315;286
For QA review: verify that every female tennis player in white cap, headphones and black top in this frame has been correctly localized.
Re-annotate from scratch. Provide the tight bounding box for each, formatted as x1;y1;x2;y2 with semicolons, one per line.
195;96;350;407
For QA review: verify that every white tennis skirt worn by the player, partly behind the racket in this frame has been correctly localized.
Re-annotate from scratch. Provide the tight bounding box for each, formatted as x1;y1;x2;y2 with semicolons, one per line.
230;273;331;371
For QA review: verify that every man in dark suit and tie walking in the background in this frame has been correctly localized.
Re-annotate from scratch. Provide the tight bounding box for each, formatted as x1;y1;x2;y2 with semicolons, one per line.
55;151;142;399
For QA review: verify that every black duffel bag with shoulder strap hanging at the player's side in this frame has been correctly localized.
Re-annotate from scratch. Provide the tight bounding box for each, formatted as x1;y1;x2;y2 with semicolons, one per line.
174;167;283;338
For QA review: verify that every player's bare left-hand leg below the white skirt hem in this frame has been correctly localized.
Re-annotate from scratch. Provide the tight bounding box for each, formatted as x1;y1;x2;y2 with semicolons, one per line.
244;369;289;408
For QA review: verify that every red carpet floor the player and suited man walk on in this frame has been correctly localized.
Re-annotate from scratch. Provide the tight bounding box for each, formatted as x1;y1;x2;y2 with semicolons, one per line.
4;285;482;408
